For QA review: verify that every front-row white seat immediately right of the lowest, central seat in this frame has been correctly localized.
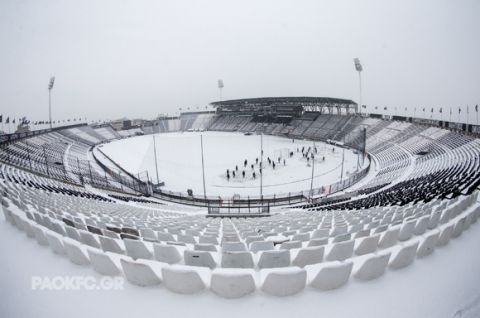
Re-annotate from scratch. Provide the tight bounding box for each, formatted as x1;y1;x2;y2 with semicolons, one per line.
262;266;307;296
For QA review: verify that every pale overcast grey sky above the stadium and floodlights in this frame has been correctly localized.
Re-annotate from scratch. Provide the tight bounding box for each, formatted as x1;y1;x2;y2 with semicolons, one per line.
0;0;480;123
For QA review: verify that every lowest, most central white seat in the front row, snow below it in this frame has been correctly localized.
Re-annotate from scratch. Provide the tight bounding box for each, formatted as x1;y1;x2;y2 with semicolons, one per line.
210;268;256;299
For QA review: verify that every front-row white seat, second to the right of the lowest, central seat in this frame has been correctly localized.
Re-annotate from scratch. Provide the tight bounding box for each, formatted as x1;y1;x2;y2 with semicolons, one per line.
310;261;353;290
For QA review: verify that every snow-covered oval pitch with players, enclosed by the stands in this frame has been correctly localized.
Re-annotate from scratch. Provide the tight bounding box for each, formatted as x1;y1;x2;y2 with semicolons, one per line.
101;132;364;196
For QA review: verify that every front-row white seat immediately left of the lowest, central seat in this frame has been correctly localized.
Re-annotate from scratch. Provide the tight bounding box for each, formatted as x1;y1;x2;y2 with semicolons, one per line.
162;265;205;294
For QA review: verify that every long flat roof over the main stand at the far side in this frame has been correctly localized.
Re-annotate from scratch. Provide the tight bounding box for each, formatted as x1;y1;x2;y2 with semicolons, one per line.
210;96;357;107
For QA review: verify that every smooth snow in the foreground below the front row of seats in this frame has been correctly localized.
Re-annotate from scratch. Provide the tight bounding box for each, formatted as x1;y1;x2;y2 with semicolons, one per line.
0;207;480;318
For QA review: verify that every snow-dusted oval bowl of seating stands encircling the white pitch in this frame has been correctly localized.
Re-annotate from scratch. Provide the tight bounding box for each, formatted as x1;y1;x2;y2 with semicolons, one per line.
0;112;480;298
